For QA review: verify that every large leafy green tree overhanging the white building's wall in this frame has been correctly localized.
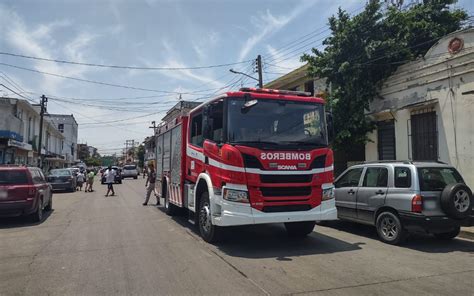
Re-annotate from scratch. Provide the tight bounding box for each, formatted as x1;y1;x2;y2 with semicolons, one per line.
301;0;468;152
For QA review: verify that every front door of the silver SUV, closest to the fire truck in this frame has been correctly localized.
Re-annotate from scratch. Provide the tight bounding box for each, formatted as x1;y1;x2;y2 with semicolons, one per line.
335;167;364;219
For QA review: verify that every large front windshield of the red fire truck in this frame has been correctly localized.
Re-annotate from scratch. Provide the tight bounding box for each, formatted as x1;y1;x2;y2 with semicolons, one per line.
227;98;327;147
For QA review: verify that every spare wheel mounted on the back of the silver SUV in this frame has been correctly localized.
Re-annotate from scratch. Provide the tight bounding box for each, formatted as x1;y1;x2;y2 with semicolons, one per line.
441;183;473;219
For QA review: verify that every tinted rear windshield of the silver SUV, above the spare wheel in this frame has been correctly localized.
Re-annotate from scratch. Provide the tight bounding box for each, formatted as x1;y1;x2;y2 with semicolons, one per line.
418;168;464;191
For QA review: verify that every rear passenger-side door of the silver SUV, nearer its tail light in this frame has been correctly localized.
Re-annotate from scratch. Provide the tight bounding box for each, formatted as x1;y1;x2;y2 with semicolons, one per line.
357;166;389;223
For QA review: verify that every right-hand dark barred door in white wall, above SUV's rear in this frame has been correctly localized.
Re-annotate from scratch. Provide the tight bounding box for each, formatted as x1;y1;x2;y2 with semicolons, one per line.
411;112;438;160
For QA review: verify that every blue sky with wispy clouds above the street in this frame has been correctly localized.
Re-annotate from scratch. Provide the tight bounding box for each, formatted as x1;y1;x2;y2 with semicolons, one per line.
0;0;474;155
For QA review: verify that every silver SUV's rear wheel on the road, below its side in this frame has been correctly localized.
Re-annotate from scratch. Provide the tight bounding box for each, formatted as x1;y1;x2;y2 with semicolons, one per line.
375;212;407;245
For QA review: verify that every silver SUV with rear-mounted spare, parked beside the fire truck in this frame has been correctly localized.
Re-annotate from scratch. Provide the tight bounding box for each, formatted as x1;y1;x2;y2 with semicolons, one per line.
335;161;474;244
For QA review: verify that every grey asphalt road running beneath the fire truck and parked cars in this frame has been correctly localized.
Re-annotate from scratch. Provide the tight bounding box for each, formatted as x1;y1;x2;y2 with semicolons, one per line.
0;179;474;295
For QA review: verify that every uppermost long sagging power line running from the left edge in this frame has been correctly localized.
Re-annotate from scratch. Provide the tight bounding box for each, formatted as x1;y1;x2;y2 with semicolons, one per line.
0;52;250;71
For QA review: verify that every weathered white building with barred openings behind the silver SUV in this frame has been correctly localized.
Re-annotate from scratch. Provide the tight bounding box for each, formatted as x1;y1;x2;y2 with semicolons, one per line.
365;28;474;188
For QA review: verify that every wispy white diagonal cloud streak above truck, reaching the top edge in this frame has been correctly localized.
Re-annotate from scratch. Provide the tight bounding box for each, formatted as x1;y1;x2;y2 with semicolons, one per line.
239;1;315;61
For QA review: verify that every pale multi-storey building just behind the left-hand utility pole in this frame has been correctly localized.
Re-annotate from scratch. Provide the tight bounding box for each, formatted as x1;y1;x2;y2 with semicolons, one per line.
47;114;78;166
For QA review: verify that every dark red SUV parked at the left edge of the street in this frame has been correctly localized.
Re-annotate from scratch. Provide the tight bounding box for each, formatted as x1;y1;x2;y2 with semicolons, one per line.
0;166;53;222
